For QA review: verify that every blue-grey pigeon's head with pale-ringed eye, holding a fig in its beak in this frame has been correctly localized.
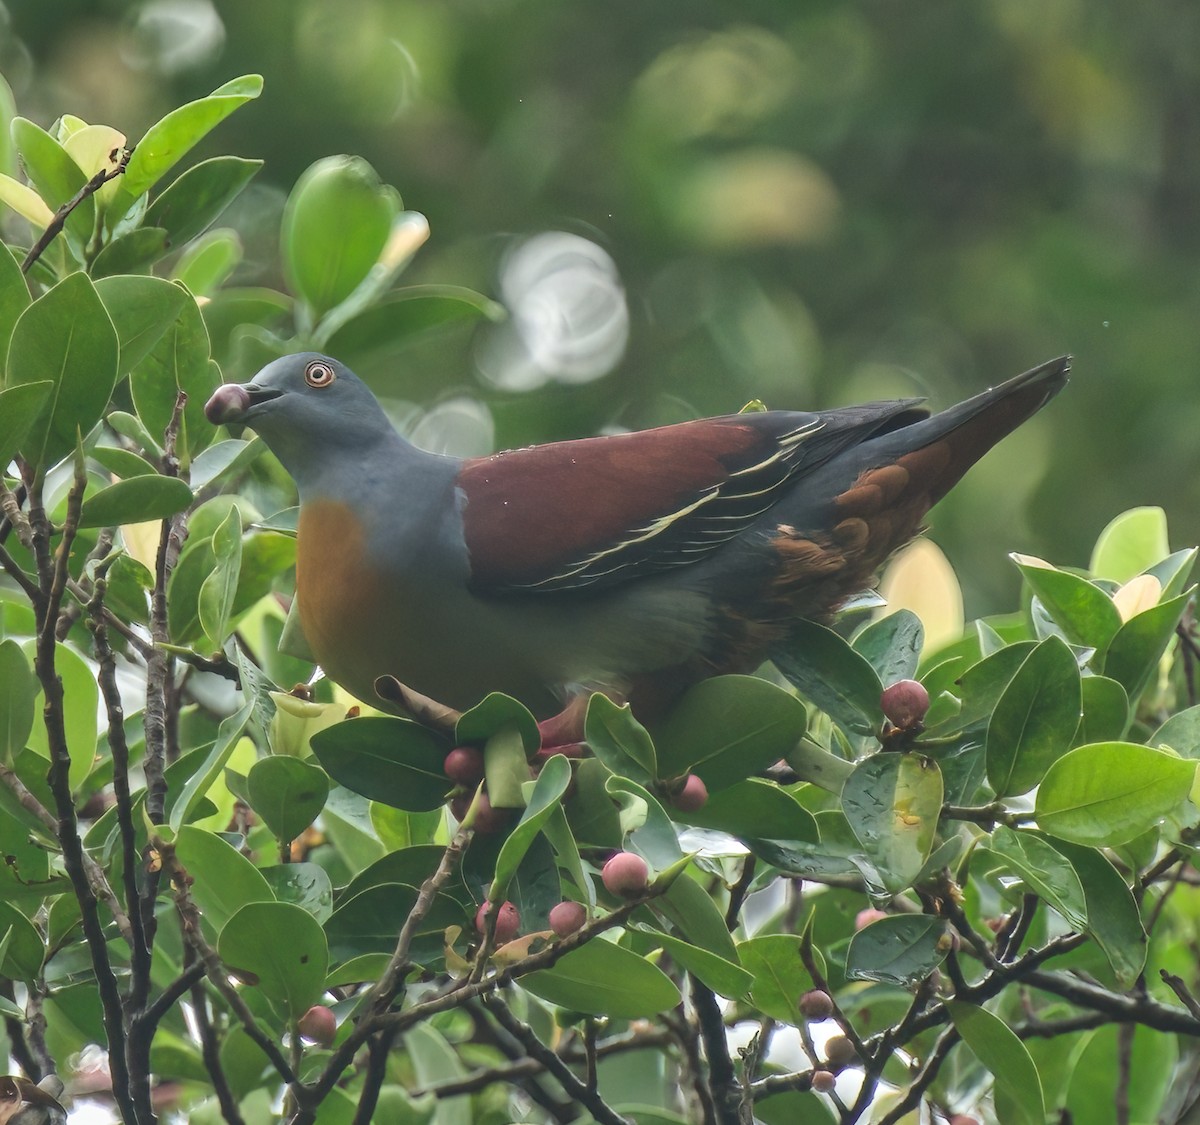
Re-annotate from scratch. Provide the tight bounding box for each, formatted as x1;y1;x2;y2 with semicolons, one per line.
204;351;395;476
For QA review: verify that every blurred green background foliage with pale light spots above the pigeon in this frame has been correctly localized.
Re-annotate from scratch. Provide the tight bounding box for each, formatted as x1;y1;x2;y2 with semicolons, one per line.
0;0;1200;615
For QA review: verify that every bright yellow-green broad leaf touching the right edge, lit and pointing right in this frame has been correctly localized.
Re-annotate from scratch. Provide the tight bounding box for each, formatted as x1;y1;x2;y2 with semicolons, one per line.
1034;742;1196;848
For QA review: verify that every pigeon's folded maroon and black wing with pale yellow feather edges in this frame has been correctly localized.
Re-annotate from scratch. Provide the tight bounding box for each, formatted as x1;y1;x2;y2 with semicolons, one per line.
458;402;924;594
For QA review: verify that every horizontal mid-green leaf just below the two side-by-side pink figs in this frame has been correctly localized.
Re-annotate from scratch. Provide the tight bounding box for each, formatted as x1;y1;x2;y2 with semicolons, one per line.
520;940;682;1019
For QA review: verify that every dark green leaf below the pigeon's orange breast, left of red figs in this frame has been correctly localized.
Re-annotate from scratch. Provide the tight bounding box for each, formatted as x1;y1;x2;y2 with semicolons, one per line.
312;716;450;812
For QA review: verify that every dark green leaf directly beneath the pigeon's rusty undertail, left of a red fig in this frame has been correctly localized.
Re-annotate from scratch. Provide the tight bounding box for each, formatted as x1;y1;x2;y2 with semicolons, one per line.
773;621;883;734
